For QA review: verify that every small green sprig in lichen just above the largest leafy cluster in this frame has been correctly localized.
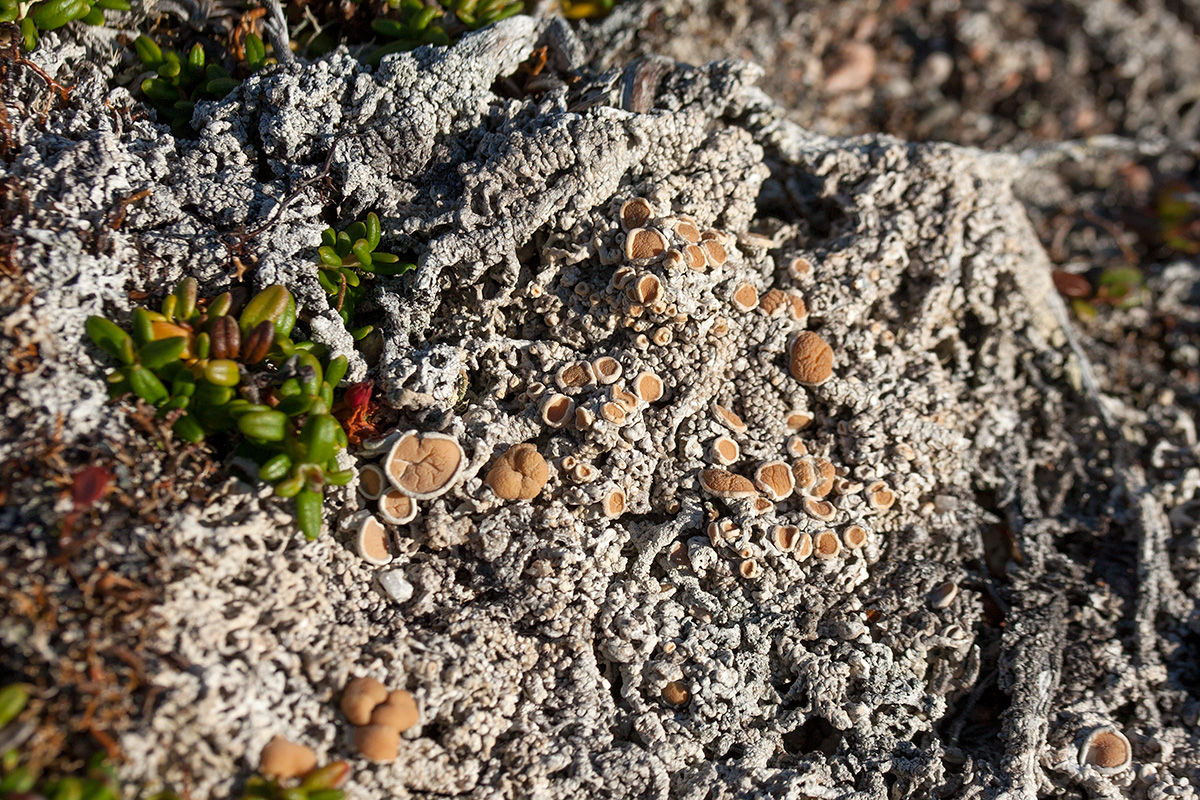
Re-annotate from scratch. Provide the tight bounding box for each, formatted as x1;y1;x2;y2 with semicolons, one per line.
317;211;416;341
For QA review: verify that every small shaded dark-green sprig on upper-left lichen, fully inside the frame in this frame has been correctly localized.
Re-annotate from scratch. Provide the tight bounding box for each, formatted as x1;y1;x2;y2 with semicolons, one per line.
133;34;271;128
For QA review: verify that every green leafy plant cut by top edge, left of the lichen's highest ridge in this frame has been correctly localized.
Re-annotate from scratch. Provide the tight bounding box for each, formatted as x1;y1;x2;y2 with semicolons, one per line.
368;0;524;65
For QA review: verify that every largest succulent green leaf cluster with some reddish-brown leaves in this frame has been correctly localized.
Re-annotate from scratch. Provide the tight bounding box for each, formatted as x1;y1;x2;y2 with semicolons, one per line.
86;278;353;539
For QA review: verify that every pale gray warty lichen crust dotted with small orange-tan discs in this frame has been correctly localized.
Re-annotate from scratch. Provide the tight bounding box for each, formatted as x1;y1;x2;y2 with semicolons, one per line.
5;10;1196;800
